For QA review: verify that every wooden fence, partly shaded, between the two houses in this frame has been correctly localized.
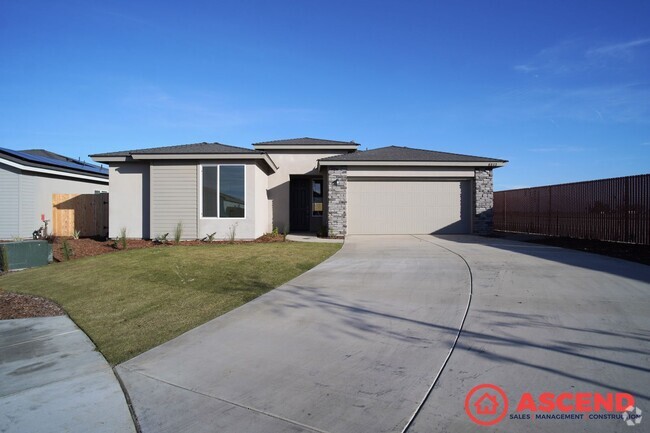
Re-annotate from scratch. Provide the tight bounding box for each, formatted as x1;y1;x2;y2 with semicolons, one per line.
51;192;108;237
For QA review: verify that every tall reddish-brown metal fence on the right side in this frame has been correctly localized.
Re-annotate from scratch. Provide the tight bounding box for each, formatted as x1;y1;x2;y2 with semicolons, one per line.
494;174;650;245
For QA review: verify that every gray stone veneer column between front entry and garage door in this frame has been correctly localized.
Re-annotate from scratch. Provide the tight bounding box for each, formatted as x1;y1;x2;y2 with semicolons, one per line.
327;167;348;236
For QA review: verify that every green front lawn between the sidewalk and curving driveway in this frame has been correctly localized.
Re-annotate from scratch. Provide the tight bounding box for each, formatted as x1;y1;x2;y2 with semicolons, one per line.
0;242;341;364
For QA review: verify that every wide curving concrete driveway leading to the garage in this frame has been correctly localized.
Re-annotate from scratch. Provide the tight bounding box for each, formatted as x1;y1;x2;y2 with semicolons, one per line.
117;236;650;433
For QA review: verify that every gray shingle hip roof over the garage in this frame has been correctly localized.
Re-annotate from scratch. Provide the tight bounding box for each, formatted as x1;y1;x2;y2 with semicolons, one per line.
320;146;507;162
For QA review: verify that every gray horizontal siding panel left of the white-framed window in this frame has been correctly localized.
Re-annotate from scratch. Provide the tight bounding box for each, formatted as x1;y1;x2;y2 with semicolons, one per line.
150;163;199;239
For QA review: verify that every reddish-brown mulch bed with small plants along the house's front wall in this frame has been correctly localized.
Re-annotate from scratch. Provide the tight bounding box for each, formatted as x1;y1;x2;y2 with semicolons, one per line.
52;234;284;262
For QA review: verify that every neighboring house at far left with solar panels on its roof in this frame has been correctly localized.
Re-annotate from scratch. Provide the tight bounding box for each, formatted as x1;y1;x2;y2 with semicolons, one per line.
0;147;108;240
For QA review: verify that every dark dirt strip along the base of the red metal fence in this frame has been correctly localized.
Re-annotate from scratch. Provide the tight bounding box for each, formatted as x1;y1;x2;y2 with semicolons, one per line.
494;232;650;265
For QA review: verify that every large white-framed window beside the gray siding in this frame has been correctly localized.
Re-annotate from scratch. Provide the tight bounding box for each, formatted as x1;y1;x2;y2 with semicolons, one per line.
201;164;246;219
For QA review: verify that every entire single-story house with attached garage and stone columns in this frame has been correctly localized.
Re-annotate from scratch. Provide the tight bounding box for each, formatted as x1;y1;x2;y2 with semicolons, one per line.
91;138;507;239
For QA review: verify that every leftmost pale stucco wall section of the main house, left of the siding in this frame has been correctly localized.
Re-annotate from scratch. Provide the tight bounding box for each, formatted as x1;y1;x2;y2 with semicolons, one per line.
108;162;151;239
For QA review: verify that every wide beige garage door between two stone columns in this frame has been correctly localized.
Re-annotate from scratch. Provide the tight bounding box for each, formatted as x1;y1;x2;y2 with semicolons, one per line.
348;179;471;234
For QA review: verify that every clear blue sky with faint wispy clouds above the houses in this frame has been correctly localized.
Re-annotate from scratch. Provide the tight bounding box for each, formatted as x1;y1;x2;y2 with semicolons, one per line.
0;0;650;189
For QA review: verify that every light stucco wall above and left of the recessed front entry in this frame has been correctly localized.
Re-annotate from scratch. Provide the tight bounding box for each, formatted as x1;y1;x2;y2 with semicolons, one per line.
266;150;347;230
